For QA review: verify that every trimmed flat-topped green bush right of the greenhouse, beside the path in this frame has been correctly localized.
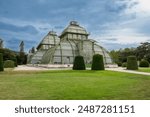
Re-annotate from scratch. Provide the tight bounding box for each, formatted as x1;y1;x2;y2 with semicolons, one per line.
127;56;138;70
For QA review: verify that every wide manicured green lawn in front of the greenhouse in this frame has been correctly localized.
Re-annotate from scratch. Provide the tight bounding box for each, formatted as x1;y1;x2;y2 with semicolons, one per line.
0;70;150;100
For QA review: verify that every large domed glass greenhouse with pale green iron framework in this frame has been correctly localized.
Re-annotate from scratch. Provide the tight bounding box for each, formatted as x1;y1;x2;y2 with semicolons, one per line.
28;21;112;64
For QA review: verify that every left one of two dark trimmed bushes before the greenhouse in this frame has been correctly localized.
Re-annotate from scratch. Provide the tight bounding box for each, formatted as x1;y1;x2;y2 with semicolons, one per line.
73;56;86;70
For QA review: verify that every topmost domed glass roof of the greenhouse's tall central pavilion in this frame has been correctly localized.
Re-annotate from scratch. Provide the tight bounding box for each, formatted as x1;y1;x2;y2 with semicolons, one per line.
60;21;89;37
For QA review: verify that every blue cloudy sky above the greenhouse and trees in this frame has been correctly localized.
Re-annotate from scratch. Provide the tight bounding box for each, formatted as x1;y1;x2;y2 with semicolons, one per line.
0;0;150;52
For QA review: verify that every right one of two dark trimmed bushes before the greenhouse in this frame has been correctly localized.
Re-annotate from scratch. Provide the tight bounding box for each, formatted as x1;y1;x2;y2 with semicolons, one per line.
91;54;105;70
